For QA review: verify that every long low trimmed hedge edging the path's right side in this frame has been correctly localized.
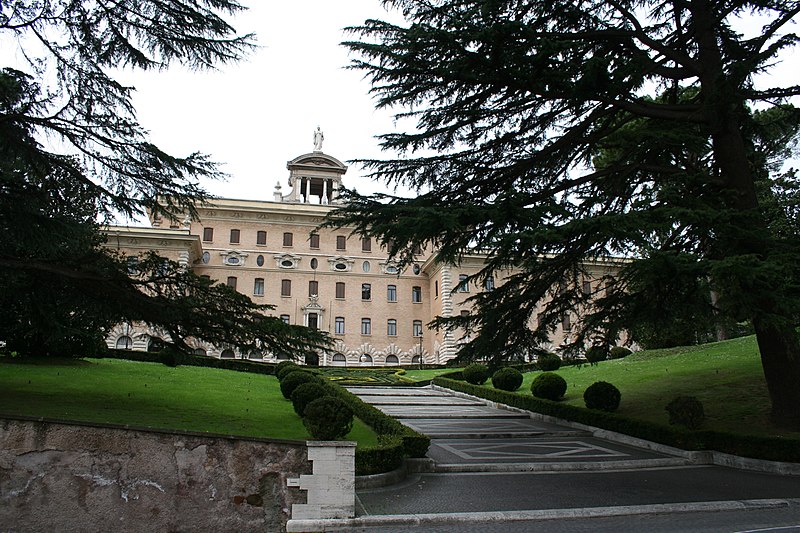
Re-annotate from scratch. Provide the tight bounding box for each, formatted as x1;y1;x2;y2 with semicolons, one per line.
433;376;800;463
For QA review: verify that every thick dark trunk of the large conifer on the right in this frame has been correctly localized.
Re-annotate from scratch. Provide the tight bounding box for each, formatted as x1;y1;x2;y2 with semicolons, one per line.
689;0;800;429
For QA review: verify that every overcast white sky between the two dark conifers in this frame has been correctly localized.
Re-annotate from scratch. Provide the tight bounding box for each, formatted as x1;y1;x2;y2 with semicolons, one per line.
117;0;406;205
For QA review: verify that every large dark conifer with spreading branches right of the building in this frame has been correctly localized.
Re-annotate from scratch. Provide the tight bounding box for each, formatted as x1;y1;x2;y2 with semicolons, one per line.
333;0;800;425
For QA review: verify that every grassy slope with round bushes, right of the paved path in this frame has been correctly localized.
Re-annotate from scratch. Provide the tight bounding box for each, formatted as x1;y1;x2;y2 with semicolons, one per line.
516;337;800;437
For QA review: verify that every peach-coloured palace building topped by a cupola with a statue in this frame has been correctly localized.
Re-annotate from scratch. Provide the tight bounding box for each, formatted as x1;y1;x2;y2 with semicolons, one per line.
106;137;616;366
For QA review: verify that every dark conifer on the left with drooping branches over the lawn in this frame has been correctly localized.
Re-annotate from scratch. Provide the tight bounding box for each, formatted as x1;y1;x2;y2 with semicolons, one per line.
0;0;328;357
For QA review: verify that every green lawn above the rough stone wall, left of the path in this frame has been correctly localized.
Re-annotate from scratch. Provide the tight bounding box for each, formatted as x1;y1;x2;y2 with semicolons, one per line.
0;359;377;446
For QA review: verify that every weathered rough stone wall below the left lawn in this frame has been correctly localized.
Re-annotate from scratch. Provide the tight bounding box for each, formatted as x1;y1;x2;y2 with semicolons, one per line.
0;419;311;533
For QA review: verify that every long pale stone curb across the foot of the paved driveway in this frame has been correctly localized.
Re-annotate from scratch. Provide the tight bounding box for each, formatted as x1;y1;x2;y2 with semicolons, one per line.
286;499;795;532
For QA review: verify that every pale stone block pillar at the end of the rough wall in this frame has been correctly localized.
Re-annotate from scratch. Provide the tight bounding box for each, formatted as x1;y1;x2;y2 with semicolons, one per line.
286;441;356;531
